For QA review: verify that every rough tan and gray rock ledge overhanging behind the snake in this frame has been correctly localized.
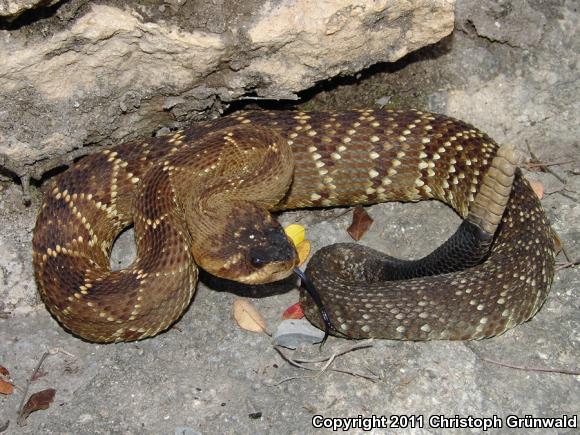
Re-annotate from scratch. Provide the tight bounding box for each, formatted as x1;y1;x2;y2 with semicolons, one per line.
0;0;454;184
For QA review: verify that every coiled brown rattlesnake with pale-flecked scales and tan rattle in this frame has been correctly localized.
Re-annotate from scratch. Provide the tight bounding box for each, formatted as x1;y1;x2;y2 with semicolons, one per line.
33;110;556;342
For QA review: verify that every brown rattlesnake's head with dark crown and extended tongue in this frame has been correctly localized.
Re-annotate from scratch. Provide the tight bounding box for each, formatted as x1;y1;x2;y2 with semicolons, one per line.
194;201;299;284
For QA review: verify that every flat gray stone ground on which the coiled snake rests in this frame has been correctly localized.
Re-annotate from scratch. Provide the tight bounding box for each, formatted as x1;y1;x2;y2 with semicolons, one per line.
0;1;580;434
